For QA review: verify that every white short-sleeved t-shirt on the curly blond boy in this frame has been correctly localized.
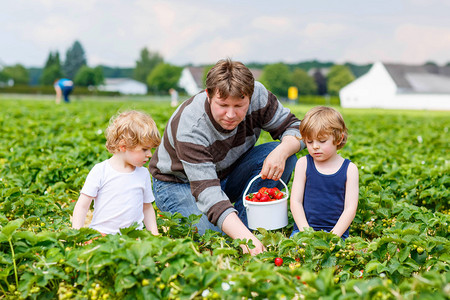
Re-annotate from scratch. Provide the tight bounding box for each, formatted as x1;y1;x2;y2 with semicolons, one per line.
81;160;155;234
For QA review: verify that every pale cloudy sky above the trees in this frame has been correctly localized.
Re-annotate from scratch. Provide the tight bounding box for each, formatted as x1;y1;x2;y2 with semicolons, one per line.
0;0;450;67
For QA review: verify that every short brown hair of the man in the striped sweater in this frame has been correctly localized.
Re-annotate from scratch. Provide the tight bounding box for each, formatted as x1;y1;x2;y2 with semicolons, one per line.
206;58;255;98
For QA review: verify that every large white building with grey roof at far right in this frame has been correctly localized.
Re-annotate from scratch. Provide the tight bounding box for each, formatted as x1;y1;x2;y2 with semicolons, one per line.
339;62;450;110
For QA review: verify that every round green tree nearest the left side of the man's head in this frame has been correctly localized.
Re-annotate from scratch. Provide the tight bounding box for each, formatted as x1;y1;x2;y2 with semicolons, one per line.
147;63;183;92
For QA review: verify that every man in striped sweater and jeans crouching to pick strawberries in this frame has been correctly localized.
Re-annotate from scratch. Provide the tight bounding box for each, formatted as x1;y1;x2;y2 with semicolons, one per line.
149;59;304;255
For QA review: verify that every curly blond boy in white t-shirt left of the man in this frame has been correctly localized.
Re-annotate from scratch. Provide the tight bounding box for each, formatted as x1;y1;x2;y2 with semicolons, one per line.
72;111;161;235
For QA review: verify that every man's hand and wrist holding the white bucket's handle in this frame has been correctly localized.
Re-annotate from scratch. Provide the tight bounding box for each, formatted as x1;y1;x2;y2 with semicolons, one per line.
260;136;300;181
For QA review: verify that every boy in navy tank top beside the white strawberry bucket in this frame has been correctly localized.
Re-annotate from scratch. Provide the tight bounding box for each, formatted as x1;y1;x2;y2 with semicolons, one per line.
290;106;359;239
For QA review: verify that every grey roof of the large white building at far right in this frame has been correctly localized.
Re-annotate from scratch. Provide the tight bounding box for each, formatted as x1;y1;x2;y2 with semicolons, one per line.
384;64;450;93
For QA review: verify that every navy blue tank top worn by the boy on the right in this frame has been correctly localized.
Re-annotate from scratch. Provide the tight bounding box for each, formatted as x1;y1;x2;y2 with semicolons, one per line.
303;154;350;239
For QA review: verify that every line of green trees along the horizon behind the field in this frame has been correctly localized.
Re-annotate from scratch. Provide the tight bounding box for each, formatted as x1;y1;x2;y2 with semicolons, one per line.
0;41;450;97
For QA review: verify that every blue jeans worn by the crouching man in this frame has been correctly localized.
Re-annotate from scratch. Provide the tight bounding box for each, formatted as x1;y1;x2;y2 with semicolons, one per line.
153;142;297;234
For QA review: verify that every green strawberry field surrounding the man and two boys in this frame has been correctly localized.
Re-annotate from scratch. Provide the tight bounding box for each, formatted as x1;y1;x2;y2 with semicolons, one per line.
0;98;450;300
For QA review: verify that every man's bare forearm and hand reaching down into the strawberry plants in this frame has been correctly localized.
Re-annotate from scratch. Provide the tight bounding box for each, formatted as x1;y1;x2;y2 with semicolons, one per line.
222;213;266;255
